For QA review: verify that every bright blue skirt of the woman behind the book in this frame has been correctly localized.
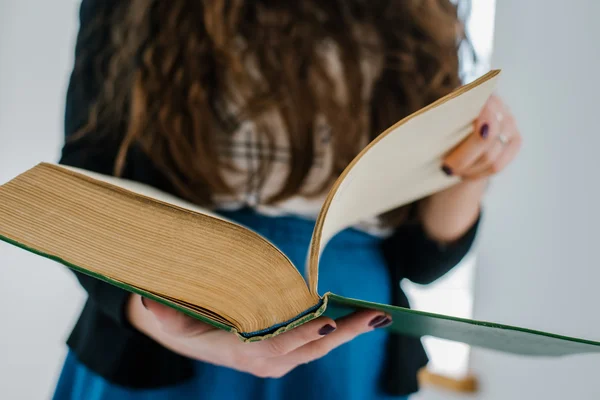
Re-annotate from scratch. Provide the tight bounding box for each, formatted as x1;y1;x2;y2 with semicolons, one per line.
54;211;405;400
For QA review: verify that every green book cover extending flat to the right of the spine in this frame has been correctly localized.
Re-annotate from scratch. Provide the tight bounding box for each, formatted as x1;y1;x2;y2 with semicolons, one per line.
325;293;600;357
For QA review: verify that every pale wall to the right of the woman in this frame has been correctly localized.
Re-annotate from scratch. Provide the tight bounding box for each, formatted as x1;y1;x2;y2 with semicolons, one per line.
472;0;600;400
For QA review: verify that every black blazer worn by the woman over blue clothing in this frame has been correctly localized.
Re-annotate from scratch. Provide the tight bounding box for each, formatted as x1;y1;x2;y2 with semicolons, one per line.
60;0;479;395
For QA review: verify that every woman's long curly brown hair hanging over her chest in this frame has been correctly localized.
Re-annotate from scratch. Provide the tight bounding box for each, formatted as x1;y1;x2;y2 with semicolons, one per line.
74;0;472;209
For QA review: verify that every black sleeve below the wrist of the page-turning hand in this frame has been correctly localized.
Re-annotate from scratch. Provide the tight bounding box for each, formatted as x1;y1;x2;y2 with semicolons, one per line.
383;215;481;284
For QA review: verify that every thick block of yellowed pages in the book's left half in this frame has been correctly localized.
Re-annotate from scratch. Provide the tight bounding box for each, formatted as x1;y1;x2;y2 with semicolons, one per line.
0;163;319;333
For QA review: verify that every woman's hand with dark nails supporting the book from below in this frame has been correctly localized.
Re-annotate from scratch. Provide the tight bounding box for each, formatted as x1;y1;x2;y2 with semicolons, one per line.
128;295;391;378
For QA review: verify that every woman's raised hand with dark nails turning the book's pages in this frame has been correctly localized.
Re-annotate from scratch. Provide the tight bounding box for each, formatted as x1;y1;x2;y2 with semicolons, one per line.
442;96;522;180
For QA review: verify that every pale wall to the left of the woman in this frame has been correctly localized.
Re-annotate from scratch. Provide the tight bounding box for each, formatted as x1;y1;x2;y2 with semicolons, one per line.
0;0;83;400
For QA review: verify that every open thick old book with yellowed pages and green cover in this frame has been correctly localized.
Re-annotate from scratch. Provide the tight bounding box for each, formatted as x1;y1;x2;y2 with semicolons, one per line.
0;71;600;356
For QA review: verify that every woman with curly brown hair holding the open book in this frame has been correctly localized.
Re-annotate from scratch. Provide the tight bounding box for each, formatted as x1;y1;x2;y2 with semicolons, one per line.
55;0;521;400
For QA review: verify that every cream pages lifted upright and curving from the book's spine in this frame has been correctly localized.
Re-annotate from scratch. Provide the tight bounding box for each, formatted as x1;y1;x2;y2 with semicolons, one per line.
307;70;499;293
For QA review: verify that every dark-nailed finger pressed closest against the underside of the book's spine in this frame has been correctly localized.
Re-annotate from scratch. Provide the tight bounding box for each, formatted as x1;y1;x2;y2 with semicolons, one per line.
245;317;337;358
